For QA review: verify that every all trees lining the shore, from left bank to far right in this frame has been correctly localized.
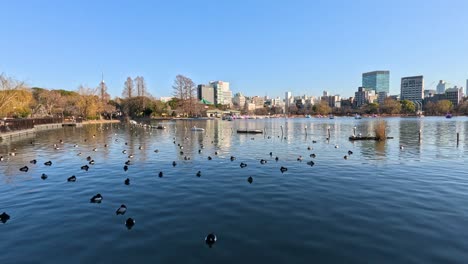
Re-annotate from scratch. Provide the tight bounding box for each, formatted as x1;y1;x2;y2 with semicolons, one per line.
0;74;468;119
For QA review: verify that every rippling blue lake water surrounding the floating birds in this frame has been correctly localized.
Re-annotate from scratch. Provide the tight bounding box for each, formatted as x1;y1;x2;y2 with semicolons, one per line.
0;117;468;263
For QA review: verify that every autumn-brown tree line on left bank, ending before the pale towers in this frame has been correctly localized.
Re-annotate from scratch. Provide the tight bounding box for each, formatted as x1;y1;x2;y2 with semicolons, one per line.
0;74;209;120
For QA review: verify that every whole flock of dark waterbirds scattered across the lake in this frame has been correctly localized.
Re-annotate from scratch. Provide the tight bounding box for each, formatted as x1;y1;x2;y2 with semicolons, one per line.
0;122;358;248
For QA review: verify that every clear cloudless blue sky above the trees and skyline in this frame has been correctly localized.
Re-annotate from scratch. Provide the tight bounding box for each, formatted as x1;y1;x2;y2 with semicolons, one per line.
0;0;468;97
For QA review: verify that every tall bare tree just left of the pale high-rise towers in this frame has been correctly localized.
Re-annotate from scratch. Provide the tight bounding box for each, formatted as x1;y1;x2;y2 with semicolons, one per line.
172;74;196;114
